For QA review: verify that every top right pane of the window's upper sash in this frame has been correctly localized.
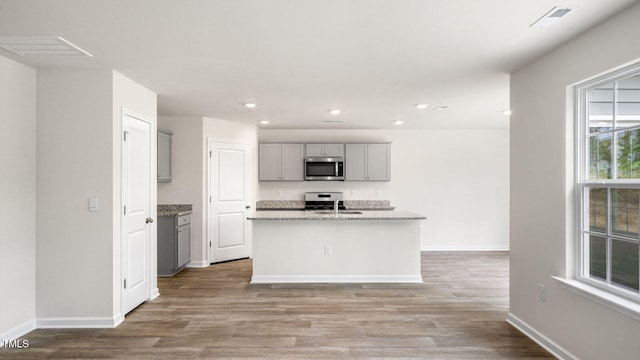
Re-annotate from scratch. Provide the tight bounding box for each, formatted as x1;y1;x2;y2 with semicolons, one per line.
616;75;640;128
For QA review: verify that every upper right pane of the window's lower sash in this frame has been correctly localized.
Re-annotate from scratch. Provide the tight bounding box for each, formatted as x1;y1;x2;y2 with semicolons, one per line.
611;189;640;238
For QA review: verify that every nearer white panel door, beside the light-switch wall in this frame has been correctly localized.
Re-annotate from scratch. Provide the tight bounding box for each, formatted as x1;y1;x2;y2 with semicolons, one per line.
121;112;152;314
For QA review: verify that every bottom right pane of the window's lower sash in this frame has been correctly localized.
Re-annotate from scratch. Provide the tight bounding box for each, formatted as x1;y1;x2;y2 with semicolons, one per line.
611;240;639;290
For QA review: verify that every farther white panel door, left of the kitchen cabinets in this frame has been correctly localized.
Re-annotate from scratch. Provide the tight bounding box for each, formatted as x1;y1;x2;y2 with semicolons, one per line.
208;141;253;263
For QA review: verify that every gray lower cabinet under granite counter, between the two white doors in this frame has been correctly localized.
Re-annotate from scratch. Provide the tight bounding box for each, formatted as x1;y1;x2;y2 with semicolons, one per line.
158;214;191;276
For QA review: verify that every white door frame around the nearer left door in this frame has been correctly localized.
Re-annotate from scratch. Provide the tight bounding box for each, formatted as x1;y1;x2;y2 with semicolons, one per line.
117;107;154;316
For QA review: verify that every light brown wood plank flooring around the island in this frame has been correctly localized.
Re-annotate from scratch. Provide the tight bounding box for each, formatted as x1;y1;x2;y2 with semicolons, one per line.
0;252;553;359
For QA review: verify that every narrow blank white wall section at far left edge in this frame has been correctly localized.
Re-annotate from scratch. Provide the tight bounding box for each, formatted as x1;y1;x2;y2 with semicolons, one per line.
0;56;36;340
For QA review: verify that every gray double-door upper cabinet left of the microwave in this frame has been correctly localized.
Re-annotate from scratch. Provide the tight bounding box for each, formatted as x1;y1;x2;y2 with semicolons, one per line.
259;144;304;181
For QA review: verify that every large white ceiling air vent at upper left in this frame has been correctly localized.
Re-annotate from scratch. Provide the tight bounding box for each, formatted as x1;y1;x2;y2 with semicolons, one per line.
0;36;93;57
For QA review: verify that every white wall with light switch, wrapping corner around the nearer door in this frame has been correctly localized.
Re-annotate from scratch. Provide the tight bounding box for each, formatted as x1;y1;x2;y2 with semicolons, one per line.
36;69;157;327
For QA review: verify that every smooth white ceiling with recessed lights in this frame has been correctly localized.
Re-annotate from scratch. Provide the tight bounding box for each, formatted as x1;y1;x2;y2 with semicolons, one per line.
0;0;638;129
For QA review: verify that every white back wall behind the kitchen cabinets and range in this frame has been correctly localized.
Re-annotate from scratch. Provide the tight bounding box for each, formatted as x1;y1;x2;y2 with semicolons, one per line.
258;129;509;250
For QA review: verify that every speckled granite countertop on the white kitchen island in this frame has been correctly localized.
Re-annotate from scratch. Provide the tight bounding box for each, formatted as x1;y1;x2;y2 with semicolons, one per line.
247;210;426;221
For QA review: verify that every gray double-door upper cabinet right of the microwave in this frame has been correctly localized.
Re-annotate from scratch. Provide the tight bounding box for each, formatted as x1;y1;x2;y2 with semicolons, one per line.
345;143;391;181
